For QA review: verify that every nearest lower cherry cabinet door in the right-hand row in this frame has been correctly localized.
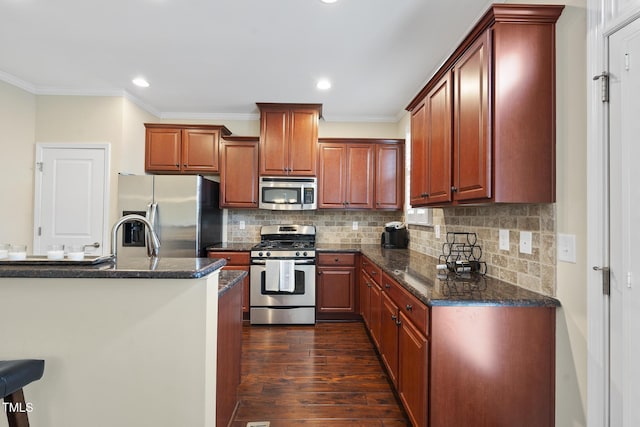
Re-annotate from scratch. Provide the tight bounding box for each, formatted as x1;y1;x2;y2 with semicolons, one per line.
398;313;429;427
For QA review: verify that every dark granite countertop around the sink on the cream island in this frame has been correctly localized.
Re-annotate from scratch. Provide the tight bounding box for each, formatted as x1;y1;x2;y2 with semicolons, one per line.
0;257;226;279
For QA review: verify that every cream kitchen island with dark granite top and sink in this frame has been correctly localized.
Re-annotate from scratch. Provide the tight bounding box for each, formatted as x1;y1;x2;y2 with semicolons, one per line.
0;258;245;427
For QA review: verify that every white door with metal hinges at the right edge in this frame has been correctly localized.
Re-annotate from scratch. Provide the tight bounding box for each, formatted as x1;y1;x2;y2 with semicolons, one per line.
609;20;640;427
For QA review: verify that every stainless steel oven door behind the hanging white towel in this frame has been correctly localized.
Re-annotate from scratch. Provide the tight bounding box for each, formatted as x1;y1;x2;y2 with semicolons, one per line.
249;260;316;307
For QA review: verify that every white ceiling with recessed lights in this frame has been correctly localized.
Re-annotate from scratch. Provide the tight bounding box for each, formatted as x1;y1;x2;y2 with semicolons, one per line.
0;0;492;122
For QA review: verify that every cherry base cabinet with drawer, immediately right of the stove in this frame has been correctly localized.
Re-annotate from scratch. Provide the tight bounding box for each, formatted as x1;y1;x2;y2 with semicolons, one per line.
316;253;357;320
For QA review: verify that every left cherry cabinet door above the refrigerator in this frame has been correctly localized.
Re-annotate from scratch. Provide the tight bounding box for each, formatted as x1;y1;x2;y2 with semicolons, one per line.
145;128;182;172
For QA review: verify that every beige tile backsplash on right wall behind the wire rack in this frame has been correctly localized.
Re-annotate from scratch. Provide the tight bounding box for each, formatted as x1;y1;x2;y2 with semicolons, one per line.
409;204;556;296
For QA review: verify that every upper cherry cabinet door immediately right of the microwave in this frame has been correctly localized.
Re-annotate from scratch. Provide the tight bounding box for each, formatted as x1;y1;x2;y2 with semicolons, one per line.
318;143;347;209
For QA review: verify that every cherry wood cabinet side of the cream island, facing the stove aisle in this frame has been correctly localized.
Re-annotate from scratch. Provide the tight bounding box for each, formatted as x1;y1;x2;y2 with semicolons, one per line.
216;274;242;426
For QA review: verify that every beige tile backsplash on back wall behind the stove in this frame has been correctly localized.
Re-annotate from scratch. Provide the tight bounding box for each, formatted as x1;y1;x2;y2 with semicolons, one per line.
227;209;402;244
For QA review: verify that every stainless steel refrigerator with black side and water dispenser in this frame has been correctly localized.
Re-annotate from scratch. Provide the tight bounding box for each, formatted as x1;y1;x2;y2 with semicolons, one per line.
118;174;222;258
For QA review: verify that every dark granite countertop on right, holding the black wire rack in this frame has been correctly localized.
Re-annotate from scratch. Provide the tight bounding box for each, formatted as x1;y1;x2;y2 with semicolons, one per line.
316;244;560;307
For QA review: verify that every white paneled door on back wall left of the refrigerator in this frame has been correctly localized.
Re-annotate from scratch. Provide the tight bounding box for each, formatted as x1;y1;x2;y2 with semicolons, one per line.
33;144;109;256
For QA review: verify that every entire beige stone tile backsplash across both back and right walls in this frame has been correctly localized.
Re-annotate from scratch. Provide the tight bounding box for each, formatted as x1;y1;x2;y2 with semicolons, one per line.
227;204;556;296
